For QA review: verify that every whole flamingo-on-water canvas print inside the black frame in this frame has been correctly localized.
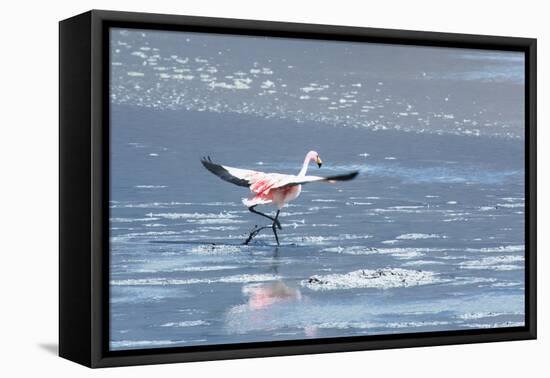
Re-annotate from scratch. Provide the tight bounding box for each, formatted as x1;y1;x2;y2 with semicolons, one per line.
109;28;525;351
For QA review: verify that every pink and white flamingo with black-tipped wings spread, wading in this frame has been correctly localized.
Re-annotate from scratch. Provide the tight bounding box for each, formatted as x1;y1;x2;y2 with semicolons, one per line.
201;151;359;245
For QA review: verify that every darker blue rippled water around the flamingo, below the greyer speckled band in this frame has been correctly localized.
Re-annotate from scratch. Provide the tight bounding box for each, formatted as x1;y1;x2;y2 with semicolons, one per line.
111;107;524;349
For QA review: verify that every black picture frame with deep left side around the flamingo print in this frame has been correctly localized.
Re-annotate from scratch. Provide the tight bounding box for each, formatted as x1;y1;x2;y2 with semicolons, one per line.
59;10;537;368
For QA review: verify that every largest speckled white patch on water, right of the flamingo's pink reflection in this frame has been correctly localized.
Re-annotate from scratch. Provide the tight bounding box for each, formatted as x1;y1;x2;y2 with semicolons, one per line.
301;268;440;291
